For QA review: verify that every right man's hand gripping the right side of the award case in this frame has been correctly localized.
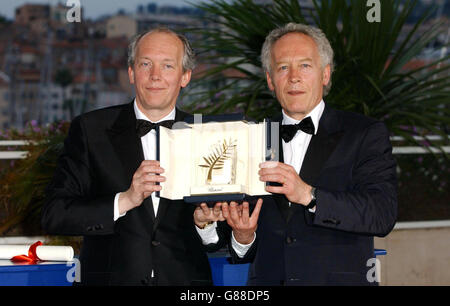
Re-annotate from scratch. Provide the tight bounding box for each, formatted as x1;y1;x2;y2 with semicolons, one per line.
258;161;312;206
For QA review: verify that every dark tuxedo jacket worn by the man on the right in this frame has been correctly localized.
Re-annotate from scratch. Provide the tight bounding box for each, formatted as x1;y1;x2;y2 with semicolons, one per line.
231;106;397;285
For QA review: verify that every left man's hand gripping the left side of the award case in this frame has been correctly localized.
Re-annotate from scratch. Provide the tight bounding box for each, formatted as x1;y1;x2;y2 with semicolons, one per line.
119;160;166;214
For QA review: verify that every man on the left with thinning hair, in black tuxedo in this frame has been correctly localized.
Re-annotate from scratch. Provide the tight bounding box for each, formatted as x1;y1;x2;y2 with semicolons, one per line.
42;28;226;285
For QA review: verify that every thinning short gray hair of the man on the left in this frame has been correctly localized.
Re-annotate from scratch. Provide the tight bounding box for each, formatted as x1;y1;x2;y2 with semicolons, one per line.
128;27;195;72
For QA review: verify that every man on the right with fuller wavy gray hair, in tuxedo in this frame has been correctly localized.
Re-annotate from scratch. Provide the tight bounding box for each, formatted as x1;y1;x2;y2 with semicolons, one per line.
222;23;397;285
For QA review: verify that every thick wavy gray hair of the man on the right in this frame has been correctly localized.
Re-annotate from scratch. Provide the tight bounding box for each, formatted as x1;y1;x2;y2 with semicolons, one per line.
261;22;334;96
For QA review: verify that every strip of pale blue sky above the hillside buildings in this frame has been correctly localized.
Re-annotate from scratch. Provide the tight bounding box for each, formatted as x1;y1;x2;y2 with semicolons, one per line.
0;0;200;19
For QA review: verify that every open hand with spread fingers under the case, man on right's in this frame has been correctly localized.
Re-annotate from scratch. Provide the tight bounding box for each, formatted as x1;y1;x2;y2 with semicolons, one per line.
222;199;263;244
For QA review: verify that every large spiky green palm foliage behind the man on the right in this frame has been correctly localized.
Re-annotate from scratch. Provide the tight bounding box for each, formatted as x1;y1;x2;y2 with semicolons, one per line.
187;0;450;148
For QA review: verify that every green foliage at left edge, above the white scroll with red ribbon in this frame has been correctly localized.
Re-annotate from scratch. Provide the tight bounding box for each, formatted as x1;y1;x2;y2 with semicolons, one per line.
0;122;69;234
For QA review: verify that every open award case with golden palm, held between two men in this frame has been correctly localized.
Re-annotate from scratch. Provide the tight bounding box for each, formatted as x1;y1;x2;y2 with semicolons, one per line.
157;115;278;203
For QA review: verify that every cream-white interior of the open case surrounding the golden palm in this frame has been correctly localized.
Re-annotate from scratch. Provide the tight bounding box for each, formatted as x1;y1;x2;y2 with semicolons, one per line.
159;121;268;200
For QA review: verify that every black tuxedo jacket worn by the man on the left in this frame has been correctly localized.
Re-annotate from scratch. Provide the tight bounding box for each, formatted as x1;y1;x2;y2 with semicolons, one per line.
42;103;224;285
